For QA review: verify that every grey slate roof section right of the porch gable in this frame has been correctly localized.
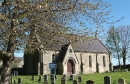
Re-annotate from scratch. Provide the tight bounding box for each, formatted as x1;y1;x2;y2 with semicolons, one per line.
72;38;110;53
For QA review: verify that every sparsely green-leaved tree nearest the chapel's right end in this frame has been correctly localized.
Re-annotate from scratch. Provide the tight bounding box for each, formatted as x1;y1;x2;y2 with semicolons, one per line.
106;26;121;66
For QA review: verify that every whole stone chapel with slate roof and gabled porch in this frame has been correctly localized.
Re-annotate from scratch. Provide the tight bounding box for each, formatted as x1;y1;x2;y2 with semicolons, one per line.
23;37;113;75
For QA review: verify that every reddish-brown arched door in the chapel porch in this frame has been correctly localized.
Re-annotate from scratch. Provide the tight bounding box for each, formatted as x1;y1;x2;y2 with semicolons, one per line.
67;59;75;75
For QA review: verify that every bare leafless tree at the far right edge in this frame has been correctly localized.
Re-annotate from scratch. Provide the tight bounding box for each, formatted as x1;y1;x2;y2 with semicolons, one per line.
118;25;130;68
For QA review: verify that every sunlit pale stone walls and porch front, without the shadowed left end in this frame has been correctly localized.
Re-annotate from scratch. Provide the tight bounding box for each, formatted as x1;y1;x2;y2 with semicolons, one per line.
43;46;111;74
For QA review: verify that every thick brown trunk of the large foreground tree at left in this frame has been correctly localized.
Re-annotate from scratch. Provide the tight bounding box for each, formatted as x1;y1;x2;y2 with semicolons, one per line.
0;19;16;84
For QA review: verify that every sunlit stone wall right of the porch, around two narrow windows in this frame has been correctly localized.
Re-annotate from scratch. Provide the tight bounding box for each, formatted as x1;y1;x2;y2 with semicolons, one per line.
76;52;110;74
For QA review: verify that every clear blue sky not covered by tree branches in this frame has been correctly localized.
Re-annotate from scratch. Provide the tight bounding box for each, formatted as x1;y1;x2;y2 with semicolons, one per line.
15;0;130;65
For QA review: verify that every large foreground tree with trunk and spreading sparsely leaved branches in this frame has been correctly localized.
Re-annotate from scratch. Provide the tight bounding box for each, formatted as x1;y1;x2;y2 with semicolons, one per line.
0;0;110;83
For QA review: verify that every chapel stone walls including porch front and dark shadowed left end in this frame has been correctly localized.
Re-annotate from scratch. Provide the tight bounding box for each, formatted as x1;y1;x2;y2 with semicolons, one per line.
24;46;111;75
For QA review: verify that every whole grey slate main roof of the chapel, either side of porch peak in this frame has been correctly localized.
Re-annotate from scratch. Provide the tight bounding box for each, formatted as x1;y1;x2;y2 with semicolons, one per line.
44;37;110;53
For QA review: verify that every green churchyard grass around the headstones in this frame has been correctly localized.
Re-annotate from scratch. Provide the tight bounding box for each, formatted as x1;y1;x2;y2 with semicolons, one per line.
10;72;130;84
